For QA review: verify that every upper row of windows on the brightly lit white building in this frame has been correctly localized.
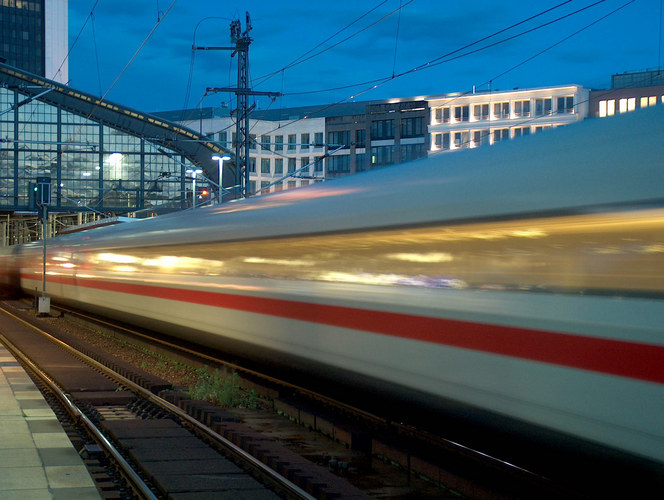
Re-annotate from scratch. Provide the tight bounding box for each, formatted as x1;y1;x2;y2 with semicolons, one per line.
432;96;575;124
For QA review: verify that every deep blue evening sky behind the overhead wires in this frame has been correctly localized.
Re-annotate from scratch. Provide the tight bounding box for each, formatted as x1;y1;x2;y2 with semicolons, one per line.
69;0;662;112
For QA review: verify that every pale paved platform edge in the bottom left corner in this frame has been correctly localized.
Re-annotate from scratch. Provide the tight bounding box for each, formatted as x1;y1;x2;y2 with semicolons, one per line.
0;344;101;500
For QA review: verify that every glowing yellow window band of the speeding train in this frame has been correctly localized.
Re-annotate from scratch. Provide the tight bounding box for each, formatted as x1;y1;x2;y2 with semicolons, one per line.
83;209;664;297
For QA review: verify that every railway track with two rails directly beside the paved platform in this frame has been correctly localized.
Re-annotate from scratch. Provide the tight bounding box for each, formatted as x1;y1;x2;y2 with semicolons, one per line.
0;305;348;499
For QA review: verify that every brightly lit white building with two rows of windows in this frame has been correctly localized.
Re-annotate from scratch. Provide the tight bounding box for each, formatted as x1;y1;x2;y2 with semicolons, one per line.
427;85;589;153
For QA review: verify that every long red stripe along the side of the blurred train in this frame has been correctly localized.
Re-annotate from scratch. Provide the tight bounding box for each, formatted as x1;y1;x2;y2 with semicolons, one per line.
23;275;664;384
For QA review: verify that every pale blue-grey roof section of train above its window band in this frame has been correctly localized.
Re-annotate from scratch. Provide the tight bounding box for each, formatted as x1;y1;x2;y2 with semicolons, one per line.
26;106;664;252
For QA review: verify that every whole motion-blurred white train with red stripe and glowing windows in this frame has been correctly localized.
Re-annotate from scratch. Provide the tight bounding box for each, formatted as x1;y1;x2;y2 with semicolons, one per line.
0;107;664;472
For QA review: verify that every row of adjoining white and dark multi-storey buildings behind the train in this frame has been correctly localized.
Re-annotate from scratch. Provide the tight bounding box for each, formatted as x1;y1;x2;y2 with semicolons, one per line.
169;85;589;195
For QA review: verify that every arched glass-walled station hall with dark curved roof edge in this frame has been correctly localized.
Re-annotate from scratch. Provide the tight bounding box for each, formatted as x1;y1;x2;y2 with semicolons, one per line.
0;64;235;243
